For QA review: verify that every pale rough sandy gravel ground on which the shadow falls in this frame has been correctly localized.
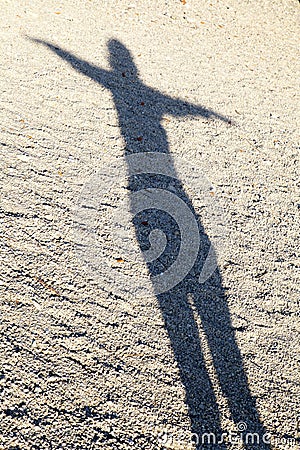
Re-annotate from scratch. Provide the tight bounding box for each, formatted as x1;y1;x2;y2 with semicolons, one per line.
0;0;300;450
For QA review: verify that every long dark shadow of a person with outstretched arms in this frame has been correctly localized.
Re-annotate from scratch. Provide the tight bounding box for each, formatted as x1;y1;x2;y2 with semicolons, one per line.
32;39;270;450
